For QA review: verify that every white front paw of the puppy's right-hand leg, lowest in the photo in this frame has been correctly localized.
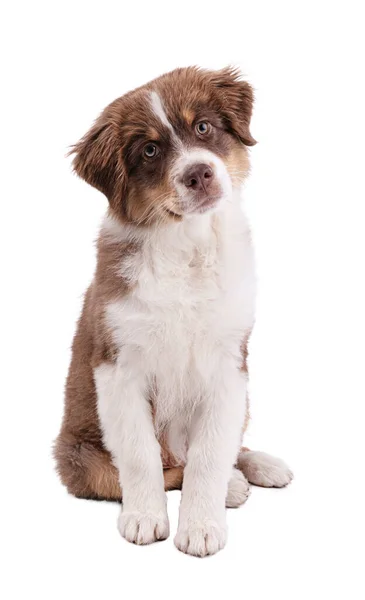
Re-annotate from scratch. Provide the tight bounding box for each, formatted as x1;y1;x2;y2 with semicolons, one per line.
174;521;227;557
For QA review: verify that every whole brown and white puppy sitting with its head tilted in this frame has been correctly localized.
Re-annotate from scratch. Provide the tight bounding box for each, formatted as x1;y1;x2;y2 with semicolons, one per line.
54;67;292;556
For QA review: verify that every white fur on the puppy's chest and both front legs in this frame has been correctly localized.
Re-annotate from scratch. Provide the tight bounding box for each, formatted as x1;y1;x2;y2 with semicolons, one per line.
95;155;255;556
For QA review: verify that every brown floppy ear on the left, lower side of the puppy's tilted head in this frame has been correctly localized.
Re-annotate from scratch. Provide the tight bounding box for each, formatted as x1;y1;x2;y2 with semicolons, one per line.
70;115;126;208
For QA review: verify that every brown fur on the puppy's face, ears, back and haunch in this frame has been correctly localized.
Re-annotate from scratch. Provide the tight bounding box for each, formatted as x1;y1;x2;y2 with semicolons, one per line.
54;67;255;500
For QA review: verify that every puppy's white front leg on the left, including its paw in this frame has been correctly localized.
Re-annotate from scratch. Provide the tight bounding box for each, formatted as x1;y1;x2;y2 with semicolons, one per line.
95;357;169;544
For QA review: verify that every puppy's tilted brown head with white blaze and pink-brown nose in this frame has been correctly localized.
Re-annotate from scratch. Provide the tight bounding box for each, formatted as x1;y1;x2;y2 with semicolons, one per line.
73;67;255;225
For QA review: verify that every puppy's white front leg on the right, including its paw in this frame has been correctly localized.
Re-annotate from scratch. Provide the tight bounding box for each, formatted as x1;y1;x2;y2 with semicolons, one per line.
175;361;247;556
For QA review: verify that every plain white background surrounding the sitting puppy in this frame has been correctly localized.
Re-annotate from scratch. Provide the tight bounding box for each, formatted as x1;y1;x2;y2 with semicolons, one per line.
0;0;365;600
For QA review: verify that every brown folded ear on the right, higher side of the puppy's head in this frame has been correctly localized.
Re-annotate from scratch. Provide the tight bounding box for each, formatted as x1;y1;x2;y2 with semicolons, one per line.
212;67;256;146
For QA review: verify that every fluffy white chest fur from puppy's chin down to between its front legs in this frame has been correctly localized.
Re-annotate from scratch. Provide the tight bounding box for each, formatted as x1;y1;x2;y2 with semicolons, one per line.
102;199;255;440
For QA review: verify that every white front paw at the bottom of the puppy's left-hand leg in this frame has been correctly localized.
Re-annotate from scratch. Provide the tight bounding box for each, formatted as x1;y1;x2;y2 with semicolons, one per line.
118;511;170;544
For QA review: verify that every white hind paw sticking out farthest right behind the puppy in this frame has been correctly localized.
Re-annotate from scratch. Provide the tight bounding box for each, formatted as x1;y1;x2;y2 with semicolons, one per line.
237;450;293;487
